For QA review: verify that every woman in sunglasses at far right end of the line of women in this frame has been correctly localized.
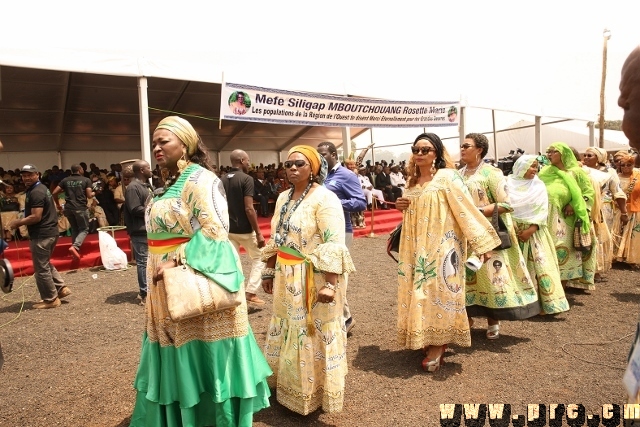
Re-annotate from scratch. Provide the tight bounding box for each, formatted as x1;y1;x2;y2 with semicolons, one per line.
613;154;640;268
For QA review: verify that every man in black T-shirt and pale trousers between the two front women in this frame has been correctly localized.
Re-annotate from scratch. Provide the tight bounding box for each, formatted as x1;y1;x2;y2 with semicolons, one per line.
222;150;265;305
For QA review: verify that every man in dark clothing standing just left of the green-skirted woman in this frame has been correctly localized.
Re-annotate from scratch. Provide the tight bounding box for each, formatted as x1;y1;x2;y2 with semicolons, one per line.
124;160;153;305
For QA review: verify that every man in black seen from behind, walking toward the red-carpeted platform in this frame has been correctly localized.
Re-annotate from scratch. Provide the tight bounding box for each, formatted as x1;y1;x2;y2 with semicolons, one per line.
53;165;93;259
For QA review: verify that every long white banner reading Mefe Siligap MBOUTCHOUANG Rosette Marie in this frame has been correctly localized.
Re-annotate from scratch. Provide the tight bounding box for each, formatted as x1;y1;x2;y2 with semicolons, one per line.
220;83;460;128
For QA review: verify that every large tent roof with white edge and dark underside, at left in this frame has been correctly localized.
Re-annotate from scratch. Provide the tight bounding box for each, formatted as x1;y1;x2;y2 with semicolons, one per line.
0;49;366;167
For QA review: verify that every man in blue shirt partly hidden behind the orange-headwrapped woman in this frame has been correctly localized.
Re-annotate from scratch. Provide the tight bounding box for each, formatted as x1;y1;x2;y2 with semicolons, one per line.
318;142;367;334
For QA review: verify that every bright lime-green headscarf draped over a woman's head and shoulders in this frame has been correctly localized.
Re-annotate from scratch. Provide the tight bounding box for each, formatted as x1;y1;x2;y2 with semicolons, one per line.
539;142;595;233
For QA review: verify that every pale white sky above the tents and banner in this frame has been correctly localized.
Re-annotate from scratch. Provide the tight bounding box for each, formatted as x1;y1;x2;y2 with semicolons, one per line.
0;0;640;155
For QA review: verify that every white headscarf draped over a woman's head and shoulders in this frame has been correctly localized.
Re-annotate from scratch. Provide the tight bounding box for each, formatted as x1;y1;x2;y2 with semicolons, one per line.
507;155;549;226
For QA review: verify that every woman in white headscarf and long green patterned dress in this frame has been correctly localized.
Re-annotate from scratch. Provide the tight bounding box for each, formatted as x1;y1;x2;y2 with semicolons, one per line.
507;155;569;314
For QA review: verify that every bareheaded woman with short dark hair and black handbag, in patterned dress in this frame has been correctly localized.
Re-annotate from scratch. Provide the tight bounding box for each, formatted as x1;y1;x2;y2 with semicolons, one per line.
460;133;540;340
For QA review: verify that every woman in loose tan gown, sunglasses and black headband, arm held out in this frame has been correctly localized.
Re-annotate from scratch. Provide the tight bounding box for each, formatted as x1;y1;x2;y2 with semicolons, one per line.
396;133;500;372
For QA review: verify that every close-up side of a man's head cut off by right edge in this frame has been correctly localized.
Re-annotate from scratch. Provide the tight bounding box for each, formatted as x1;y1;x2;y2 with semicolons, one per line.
618;46;640;155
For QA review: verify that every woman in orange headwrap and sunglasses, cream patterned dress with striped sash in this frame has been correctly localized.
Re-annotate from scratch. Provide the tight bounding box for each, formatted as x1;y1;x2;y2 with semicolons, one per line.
262;145;355;415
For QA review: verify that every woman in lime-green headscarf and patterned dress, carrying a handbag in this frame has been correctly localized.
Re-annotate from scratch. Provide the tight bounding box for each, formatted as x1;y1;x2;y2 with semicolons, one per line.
539;142;597;289
